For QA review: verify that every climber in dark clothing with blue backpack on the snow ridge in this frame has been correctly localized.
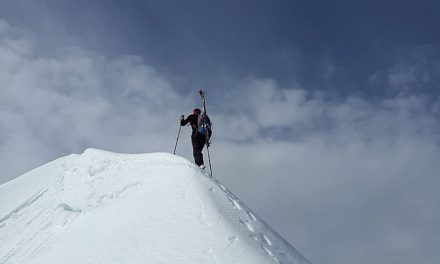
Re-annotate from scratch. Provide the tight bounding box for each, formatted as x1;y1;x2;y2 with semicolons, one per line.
180;108;212;169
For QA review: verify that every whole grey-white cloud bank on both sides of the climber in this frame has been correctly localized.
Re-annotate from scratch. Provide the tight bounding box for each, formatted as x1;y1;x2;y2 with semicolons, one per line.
0;21;440;263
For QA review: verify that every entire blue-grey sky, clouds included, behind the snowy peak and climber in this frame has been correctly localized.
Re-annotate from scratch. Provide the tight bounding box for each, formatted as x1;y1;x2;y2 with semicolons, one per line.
0;0;440;264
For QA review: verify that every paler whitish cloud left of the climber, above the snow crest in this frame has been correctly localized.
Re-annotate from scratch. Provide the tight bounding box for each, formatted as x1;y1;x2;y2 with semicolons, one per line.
0;22;192;181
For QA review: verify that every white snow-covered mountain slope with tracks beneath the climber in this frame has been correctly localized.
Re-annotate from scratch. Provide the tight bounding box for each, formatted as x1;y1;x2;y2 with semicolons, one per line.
0;149;309;264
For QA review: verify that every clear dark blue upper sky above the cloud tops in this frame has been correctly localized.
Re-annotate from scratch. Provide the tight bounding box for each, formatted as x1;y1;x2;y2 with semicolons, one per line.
6;0;439;95
